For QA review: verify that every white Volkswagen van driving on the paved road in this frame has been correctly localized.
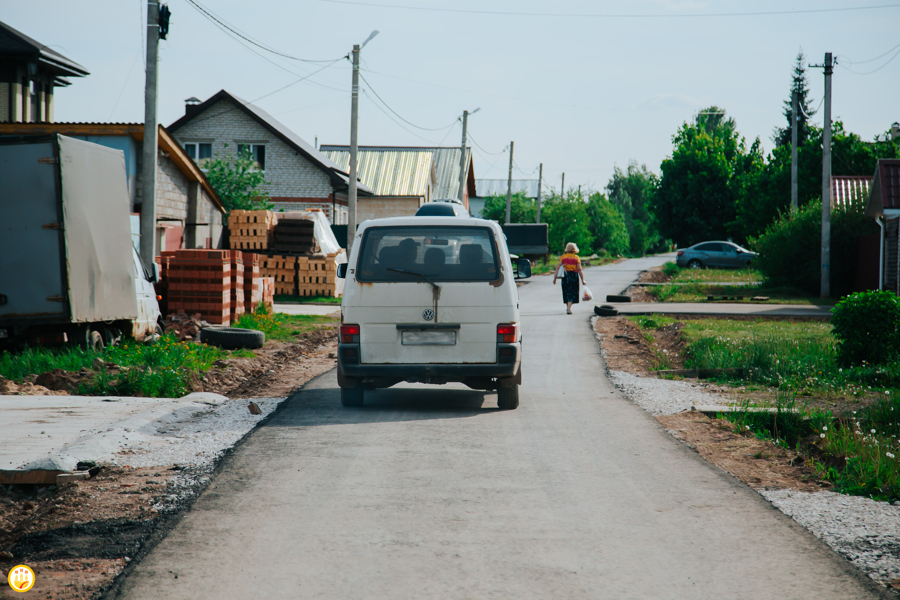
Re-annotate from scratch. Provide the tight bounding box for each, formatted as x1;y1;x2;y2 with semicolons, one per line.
338;216;531;409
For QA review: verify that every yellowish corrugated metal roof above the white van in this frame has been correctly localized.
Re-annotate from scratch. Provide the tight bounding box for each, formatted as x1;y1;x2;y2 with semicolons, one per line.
321;146;433;198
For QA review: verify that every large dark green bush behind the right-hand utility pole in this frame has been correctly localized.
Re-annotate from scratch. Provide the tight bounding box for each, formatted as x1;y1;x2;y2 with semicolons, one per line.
754;201;875;297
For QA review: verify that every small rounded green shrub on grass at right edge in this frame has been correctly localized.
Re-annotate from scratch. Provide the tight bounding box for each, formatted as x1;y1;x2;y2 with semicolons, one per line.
831;291;900;366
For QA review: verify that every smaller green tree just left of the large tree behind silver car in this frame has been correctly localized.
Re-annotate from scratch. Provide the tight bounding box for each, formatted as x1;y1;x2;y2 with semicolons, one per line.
606;160;666;255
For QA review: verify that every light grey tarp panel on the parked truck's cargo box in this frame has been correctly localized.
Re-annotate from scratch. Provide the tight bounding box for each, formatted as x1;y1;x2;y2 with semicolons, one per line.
59;135;138;323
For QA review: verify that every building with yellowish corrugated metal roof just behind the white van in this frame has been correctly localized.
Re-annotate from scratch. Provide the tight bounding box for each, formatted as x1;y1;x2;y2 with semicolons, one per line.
319;145;475;222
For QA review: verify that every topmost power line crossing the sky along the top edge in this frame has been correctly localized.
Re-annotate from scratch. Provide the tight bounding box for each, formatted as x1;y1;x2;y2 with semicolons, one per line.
312;0;900;19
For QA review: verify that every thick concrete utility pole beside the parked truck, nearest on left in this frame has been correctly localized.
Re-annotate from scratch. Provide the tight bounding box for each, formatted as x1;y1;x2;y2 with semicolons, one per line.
141;0;159;269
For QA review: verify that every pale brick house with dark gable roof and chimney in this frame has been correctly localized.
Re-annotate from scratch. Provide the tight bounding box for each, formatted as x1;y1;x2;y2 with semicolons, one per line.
168;90;372;224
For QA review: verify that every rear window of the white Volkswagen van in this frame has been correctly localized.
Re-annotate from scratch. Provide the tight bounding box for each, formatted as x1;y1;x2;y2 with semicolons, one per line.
356;225;500;282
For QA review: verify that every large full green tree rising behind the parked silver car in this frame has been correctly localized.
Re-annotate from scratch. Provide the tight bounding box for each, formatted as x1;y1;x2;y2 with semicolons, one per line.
652;106;758;246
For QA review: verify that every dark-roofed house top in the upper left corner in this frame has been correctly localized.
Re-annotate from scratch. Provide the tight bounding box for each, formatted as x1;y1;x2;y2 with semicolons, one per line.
0;23;89;123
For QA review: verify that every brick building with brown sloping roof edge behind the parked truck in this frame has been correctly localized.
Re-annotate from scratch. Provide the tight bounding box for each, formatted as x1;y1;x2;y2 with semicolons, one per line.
0;123;225;251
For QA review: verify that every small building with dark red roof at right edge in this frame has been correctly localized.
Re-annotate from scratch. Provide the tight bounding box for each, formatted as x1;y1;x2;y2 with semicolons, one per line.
866;158;900;294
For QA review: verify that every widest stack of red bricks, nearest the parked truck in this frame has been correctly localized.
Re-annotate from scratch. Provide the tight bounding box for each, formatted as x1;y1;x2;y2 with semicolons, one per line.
166;250;234;325
